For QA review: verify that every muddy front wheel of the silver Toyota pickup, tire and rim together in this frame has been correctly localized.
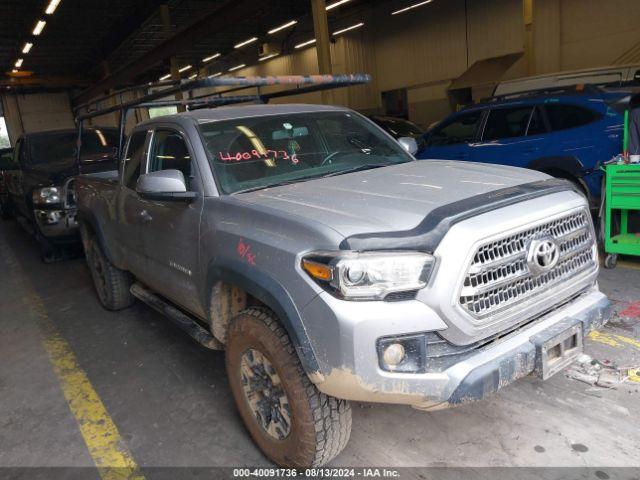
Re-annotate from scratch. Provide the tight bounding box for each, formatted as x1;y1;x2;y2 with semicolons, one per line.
226;308;351;468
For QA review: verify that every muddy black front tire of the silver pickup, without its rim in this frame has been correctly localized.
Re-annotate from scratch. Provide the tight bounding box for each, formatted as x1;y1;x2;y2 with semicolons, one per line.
226;308;351;468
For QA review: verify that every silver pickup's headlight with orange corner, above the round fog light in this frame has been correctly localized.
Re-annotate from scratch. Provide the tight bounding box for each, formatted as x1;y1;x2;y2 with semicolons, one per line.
302;252;434;300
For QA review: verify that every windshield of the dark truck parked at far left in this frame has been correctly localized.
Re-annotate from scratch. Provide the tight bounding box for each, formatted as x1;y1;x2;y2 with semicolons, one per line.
29;128;118;164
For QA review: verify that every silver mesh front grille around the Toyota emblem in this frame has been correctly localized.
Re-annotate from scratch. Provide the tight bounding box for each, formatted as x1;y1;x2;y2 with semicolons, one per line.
459;210;597;323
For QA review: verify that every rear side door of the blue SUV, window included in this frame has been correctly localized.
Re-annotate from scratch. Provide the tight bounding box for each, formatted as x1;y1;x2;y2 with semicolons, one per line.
471;105;546;167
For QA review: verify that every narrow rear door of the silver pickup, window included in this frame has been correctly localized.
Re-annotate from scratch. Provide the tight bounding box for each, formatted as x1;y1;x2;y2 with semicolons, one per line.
114;130;151;280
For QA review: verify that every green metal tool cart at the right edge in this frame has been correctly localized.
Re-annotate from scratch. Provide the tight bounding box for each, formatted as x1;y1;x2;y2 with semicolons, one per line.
604;164;640;268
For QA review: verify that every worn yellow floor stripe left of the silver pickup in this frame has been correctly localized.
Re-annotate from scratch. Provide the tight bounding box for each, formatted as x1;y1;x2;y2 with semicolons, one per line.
2;246;144;480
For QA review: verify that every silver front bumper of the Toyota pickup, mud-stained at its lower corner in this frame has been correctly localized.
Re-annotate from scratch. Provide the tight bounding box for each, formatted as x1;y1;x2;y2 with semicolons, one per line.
303;287;611;409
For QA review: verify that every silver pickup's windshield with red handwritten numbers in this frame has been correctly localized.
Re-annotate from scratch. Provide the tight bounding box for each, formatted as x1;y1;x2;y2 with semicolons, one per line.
200;112;413;194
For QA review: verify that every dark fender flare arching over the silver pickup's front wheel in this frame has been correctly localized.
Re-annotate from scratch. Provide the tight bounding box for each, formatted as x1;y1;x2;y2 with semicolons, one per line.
204;258;322;379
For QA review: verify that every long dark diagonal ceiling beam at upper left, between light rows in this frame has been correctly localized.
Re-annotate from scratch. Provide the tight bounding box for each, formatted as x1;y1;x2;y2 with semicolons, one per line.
73;0;256;104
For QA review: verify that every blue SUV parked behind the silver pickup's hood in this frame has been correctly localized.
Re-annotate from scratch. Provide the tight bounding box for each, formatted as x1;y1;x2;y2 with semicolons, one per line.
416;89;624;208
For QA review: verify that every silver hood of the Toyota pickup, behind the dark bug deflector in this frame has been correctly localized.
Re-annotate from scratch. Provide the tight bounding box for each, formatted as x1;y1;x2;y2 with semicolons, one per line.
236;160;550;237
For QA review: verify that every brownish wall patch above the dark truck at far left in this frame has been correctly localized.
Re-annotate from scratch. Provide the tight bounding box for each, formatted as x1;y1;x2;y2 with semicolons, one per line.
0;92;74;144
